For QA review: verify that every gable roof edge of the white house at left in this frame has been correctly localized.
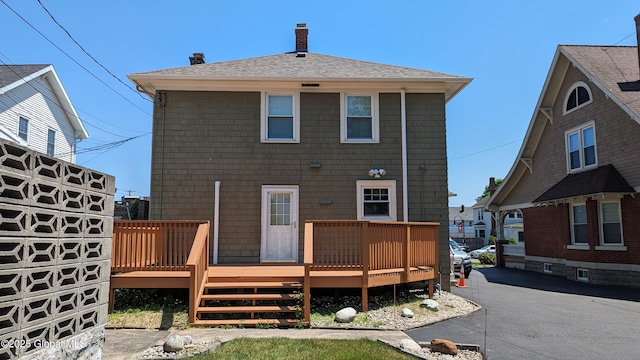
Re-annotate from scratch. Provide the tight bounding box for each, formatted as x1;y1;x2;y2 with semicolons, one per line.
0;65;89;139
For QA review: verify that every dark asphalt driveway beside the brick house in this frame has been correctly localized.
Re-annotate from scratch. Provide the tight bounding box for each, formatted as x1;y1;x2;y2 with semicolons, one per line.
406;268;640;360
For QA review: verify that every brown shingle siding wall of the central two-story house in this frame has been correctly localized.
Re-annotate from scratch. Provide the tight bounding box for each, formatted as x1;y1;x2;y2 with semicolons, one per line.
150;89;447;263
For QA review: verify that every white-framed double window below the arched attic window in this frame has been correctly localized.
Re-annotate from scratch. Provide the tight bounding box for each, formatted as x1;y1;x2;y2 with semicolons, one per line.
565;122;597;172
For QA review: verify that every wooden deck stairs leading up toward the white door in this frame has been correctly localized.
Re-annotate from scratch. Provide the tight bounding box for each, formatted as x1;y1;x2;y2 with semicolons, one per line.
195;276;304;327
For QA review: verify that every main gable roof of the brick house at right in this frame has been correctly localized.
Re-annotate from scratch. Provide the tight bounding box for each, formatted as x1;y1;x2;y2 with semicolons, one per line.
487;45;640;210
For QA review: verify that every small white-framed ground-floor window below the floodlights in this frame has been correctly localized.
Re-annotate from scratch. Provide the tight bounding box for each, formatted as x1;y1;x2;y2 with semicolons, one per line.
356;180;397;220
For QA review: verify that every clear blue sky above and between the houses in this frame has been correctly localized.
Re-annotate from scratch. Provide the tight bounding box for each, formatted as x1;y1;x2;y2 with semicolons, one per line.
0;0;640;206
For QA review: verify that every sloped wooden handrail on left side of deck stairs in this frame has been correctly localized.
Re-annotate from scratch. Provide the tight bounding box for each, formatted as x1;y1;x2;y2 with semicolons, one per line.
187;221;210;324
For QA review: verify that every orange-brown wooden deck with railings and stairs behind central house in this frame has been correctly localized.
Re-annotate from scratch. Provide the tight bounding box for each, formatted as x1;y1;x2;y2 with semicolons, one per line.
109;221;438;326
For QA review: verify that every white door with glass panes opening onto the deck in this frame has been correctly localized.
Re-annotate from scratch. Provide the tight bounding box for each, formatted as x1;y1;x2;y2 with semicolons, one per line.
260;186;298;262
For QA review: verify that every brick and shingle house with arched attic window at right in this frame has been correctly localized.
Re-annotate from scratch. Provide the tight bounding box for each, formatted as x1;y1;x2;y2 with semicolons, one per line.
487;16;640;287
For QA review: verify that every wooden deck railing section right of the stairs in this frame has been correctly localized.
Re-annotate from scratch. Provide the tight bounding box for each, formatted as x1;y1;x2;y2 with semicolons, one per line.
304;220;439;321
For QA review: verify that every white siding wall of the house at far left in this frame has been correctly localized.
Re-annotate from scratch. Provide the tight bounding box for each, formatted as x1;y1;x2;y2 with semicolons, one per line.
0;78;75;162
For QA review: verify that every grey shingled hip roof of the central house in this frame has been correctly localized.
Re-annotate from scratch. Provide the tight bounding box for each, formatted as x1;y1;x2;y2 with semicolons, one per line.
127;52;471;101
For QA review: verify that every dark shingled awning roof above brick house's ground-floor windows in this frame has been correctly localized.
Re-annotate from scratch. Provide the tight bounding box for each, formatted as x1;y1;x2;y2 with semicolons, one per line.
533;164;635;203
